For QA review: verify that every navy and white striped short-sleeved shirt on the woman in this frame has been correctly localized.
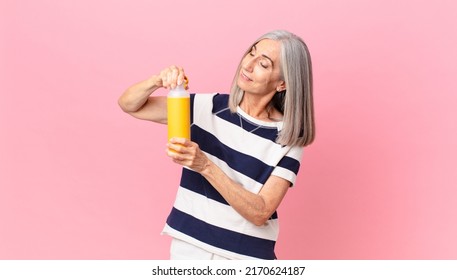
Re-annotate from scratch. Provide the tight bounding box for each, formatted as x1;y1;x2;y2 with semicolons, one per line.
163;94;303;259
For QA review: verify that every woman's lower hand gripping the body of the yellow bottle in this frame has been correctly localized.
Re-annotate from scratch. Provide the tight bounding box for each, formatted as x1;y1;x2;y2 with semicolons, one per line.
167;138;210;173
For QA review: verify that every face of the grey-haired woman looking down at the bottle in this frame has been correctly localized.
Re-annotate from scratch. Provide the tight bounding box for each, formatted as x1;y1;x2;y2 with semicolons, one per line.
237;39;285;95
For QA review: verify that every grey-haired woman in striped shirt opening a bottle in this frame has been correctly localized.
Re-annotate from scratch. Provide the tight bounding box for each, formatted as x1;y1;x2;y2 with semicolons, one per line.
119;30;314;259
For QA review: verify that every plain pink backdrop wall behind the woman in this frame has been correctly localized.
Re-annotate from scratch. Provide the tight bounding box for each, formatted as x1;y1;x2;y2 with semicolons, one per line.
0;0;457;259
